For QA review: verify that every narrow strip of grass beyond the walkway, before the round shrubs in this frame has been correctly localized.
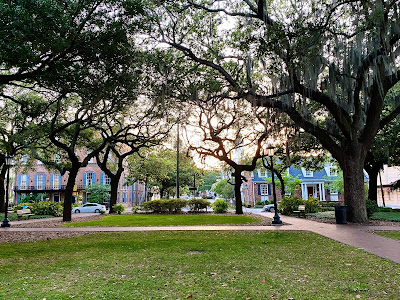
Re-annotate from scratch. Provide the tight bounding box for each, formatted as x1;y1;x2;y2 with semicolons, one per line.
66;214;260;227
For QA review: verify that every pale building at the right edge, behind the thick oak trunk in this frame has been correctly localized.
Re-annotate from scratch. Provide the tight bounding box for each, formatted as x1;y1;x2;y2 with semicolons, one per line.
377;165;400;208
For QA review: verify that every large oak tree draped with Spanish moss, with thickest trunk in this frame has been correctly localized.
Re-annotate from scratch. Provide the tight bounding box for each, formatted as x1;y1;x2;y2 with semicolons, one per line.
140;0;400;222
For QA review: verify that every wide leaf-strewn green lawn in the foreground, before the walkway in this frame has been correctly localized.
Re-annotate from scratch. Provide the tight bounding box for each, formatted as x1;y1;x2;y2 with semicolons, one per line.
0;231;400;300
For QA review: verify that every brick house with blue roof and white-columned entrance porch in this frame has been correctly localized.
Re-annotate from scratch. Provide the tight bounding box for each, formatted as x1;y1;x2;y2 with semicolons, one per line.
242;164;354;205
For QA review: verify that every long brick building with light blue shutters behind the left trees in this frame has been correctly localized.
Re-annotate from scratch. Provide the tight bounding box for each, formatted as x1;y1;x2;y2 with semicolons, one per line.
13;152;145;207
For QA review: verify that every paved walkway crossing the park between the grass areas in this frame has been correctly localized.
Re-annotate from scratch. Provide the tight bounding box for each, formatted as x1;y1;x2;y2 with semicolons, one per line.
0;212;400;264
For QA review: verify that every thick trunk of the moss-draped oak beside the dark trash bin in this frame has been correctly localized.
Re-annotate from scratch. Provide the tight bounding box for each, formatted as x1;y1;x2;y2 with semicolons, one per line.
340;157;368;223
